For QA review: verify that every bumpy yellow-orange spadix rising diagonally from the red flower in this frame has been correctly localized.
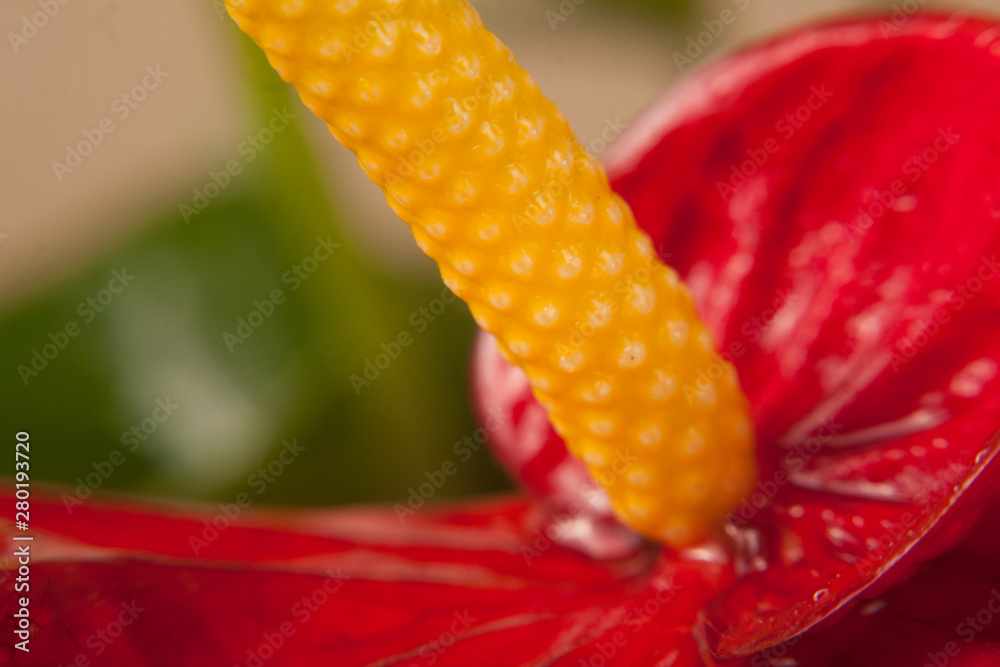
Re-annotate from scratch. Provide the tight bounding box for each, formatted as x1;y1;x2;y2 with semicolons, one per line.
227;0;756;546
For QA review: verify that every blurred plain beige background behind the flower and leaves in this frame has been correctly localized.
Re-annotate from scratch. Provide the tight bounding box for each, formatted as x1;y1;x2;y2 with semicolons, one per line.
0;0;1000;303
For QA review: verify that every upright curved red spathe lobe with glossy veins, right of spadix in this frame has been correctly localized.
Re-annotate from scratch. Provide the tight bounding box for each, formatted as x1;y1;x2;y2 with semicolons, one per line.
474;17;1000;657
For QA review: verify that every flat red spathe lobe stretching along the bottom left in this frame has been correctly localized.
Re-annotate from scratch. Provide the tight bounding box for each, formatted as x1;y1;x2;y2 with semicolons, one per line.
0;494;730;667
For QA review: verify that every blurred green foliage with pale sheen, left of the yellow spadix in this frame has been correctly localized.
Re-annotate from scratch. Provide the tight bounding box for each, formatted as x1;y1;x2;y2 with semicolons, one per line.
0;22;505;504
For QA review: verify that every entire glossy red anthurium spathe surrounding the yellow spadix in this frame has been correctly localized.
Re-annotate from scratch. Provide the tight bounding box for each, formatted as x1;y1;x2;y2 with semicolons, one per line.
0;9;1000;667
